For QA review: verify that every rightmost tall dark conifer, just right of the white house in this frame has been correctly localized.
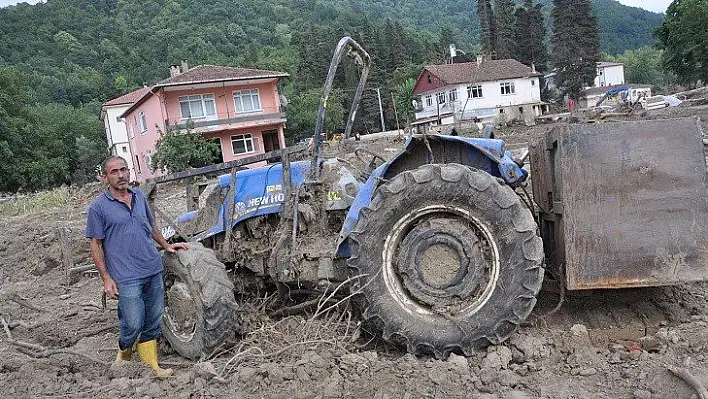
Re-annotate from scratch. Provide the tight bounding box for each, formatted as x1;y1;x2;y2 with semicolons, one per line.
551;0;600;100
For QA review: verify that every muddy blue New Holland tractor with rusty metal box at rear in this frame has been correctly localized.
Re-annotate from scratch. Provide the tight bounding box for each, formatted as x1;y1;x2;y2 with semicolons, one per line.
146;37;708;359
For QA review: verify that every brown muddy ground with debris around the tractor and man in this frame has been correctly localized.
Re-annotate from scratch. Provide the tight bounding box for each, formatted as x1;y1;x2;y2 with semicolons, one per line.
0;106;708;399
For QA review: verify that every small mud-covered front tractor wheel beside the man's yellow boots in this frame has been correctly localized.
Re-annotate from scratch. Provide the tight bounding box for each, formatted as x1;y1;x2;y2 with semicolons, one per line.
162;243;238;360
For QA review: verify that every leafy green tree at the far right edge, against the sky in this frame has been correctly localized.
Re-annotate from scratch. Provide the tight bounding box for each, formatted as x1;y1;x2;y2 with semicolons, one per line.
655;0;708;84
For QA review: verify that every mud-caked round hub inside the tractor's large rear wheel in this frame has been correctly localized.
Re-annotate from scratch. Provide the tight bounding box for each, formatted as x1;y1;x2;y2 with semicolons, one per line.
383;205;499;314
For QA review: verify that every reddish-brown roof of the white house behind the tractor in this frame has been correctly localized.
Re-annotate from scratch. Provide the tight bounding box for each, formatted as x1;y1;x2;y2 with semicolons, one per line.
413;59;543;94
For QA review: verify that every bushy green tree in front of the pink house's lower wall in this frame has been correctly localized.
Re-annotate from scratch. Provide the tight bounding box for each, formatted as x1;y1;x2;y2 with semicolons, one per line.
150;129;221;172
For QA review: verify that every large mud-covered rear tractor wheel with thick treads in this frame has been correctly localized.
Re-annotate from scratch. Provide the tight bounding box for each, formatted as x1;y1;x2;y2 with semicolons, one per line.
348;164;544;358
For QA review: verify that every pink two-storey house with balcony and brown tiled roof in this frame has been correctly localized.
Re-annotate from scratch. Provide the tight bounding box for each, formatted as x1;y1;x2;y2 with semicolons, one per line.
121;61;288;181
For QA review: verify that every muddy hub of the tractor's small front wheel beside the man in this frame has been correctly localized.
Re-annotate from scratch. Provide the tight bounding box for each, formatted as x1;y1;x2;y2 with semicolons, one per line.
165;276;197;342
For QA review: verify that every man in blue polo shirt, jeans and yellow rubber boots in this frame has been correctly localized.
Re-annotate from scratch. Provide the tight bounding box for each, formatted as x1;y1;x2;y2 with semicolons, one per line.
86;156;187;378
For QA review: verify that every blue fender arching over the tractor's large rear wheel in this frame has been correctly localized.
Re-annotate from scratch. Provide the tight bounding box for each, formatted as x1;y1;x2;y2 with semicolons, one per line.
336;135;528;258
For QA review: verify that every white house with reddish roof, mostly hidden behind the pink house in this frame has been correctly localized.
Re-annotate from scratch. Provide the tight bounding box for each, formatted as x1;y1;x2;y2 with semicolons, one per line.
101;87;150;176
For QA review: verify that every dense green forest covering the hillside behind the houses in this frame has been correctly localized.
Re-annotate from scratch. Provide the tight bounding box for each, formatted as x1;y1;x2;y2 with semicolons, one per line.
0;0;676;192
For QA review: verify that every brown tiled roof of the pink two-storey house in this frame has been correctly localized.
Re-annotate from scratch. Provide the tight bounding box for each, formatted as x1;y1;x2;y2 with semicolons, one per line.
155;65;289;87
